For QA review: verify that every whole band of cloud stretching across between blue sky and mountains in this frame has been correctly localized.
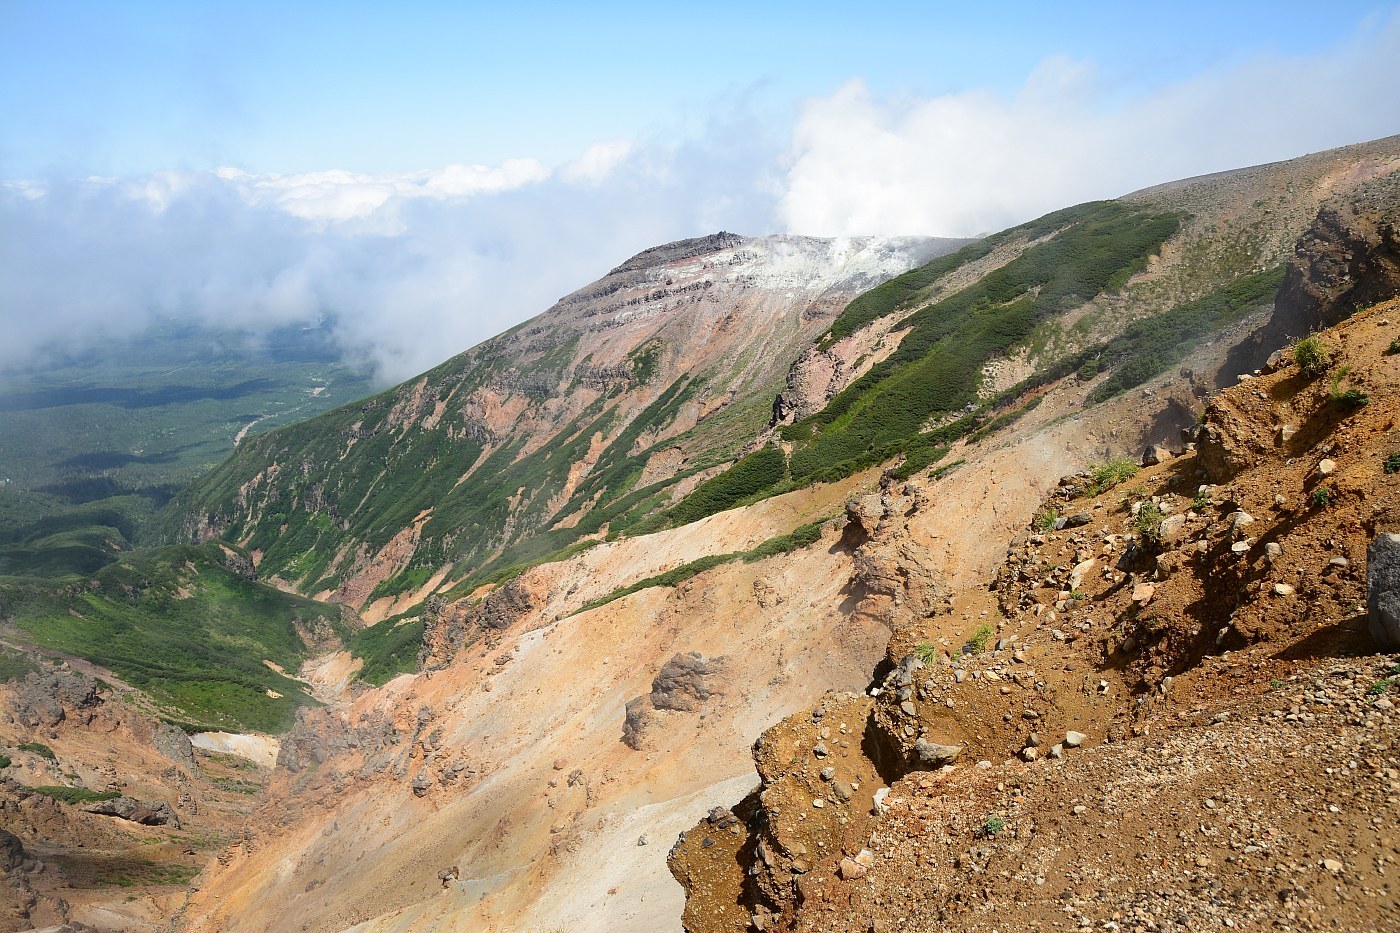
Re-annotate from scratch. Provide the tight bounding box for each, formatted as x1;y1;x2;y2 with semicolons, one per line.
0;17;1400;381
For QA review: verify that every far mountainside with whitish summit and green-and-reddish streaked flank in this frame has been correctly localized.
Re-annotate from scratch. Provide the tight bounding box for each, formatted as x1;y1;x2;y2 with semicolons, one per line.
158;234;959;612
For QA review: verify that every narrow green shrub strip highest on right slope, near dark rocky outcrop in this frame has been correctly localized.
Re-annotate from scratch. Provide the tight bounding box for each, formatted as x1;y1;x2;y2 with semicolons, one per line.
1081;266;1284;405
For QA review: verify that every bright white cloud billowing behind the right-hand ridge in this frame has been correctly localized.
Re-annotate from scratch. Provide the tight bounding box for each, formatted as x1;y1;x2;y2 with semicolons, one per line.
778;15;1400;235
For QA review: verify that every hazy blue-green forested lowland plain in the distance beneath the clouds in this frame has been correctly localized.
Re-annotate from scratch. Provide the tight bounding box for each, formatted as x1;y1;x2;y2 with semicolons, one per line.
0;321;368;577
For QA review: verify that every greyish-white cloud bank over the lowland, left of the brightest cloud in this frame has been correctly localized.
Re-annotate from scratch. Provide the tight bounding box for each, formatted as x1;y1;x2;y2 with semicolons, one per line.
0;127;774;382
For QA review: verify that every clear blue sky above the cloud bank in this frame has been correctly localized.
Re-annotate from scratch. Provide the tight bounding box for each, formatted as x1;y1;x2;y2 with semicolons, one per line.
0;0;1389;178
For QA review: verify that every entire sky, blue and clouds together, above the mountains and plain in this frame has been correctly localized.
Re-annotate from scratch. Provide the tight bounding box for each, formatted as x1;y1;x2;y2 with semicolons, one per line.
0;0;1400;382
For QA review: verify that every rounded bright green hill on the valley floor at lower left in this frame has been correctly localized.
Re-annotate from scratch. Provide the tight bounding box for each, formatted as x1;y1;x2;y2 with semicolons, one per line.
0;542;349;733
